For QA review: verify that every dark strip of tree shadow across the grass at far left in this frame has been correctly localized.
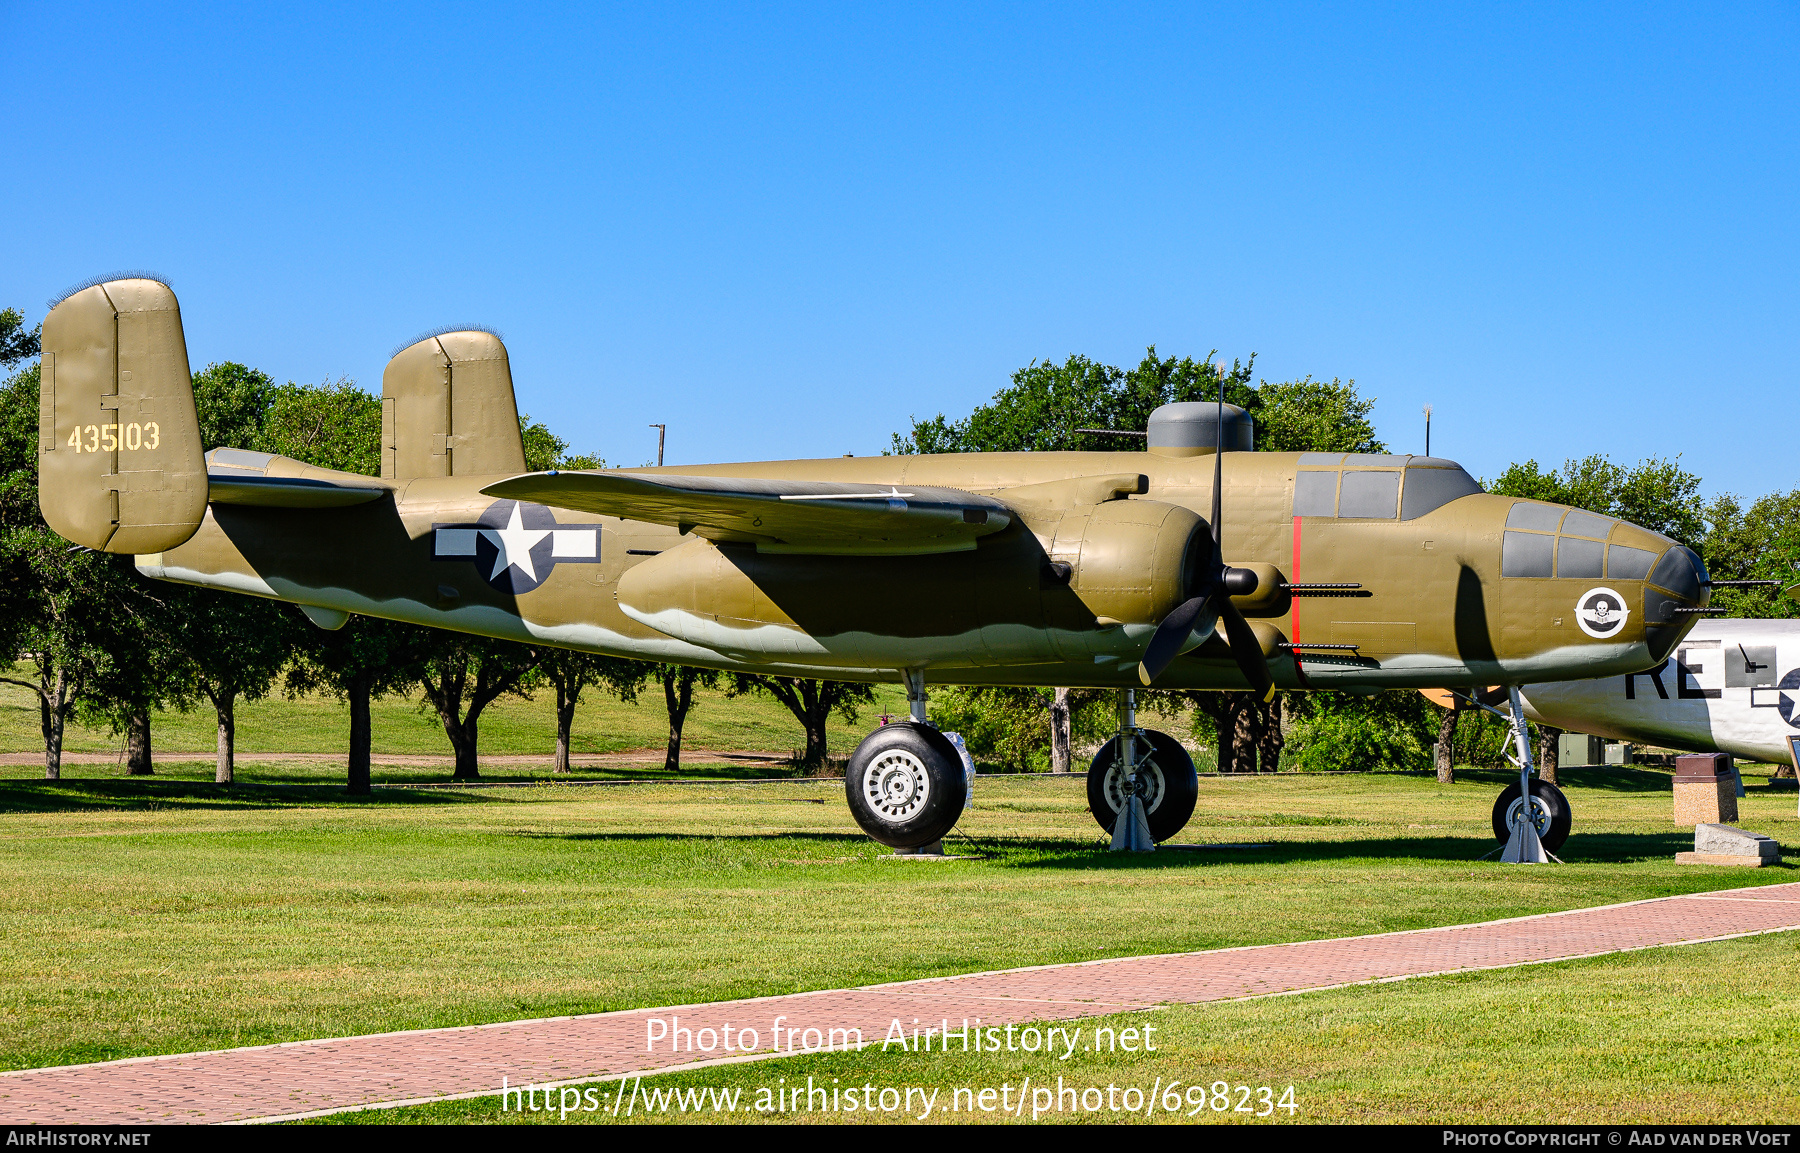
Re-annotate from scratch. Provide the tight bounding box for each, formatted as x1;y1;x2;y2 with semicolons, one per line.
0;777;484;813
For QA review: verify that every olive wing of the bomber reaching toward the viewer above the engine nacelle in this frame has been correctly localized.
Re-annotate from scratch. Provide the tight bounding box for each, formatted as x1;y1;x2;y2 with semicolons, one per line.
481;471;1012;556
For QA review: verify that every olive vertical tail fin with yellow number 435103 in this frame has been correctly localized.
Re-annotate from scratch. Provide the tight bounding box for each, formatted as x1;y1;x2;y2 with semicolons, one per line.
38;277;207;552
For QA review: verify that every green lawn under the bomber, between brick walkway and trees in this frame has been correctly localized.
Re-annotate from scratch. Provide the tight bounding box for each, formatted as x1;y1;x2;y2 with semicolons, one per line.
0;764;1800;1093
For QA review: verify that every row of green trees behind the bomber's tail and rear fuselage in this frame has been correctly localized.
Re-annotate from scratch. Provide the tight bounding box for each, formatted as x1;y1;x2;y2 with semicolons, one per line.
0;309;873;793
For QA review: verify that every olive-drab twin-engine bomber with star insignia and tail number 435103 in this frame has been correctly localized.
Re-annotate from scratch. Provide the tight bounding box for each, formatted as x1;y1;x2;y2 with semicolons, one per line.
28;279;1708;847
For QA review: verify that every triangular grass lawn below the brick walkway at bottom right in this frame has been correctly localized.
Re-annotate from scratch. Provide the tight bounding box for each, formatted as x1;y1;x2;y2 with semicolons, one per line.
358;934;1800;1124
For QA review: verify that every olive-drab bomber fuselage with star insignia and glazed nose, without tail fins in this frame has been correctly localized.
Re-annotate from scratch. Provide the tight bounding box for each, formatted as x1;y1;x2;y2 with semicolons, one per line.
137;451;1703;689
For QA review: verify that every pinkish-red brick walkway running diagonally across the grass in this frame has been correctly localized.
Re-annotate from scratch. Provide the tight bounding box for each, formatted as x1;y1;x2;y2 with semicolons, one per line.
0;883;1800;1124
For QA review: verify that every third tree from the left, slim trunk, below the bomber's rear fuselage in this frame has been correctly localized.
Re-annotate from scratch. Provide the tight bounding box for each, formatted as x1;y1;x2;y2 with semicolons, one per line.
169;588;299;784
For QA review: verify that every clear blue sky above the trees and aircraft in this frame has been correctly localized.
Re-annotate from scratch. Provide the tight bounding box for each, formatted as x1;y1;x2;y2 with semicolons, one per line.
0;2;1800;495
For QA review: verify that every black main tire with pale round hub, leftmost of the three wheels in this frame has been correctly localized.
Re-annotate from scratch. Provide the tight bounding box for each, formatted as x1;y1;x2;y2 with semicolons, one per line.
844;721;968;849
